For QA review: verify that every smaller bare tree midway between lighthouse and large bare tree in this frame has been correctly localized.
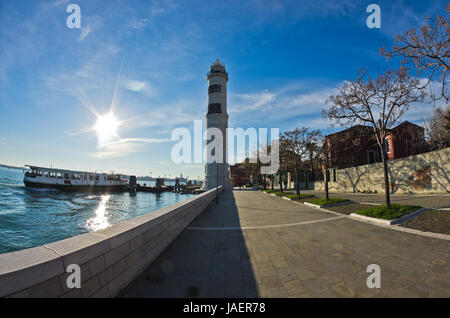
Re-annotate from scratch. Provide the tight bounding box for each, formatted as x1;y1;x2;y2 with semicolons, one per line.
280;127;320;194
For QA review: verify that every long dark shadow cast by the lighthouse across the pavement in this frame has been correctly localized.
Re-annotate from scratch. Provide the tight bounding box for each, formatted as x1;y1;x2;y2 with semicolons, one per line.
118;191;259;298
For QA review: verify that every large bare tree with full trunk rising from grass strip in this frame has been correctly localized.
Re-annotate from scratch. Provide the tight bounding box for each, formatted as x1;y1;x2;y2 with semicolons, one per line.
322;67;424;207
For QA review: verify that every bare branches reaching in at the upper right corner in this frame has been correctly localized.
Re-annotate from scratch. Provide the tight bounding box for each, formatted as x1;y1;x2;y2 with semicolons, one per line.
380;4;450;102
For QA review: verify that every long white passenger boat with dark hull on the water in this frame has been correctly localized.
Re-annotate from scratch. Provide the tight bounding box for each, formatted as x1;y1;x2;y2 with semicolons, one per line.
23;165;128;191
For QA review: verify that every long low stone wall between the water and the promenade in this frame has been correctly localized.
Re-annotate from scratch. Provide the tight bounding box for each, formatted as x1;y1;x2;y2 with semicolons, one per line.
0;187;222;297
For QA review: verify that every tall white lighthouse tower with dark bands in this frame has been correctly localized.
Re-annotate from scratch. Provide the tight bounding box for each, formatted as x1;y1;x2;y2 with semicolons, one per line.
203;60;230;190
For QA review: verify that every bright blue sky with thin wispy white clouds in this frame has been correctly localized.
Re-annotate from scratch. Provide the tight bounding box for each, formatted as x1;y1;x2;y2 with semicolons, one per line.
0;0;445;178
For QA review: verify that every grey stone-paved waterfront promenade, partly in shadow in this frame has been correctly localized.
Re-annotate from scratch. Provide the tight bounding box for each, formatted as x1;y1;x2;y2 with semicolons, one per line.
119;190;450;297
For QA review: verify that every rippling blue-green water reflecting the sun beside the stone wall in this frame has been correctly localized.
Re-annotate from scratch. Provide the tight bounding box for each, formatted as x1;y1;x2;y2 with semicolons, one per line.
0;167;193;254
